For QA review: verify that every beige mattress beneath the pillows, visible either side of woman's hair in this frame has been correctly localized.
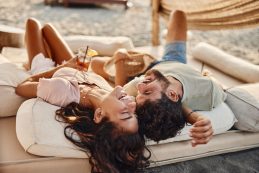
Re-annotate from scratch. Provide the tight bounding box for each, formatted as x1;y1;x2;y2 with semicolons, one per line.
0;117;259;173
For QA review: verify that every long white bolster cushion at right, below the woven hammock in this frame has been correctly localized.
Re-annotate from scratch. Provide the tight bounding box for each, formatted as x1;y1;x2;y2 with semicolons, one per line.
192;42;259;83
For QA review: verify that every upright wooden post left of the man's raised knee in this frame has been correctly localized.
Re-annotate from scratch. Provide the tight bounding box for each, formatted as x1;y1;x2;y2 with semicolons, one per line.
152;0;160;46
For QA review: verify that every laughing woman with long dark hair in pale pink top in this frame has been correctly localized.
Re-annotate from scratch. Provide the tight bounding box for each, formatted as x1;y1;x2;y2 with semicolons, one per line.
16;19;150;173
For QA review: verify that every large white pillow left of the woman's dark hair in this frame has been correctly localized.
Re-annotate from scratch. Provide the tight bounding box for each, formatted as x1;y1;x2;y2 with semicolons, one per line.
16;98;87;158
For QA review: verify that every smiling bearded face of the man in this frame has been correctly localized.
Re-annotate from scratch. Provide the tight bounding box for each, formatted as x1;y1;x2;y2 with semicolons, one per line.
136;70;169;105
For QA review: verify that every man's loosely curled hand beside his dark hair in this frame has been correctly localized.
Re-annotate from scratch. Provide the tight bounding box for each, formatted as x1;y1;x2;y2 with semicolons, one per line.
190;115;213;147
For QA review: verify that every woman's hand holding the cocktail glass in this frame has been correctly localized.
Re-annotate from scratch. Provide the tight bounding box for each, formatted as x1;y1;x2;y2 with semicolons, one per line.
63;57;90;71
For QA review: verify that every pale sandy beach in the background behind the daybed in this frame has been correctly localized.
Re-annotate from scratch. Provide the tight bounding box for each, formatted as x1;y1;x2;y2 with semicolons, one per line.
0;0;259;65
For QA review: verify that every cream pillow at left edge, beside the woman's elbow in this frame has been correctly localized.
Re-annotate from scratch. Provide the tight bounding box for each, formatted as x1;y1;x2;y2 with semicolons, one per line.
0;55;29;117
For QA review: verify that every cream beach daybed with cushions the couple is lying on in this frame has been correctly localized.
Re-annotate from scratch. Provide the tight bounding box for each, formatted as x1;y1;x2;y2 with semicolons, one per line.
0;36;259;173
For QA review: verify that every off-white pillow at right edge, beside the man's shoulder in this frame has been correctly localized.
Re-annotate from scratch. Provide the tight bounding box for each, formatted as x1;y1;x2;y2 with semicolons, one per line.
226;83;259;132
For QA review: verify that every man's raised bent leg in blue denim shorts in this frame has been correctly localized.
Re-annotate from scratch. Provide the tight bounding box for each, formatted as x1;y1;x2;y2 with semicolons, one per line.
162;10;187;63
